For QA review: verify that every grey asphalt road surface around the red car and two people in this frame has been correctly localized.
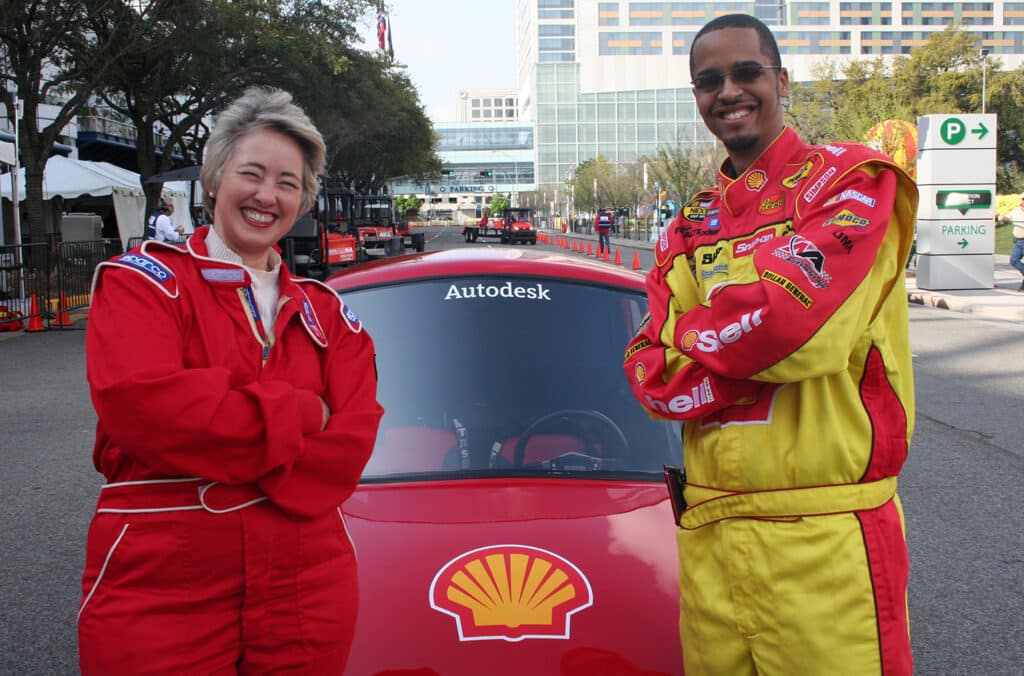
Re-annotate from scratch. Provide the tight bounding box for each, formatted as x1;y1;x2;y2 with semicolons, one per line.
0;229;1024;676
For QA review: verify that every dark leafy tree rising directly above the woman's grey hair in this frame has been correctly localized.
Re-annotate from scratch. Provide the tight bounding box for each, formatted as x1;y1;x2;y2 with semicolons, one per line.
94;0;373;214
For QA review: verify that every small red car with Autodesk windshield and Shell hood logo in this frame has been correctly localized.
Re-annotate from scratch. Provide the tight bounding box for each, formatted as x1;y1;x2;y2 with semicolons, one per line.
328;249;682;676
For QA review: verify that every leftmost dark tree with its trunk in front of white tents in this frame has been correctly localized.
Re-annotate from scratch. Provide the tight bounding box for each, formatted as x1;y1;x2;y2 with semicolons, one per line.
0;0;137;242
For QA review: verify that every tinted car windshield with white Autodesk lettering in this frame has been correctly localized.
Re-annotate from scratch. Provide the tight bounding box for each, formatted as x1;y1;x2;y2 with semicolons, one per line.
342;277;682;482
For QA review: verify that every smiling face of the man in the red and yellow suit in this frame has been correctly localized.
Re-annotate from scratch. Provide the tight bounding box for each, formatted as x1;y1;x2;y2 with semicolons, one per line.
692;28;790;171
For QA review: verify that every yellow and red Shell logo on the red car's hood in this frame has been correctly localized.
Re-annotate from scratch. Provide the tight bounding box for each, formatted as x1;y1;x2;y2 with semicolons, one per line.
430;545;594;641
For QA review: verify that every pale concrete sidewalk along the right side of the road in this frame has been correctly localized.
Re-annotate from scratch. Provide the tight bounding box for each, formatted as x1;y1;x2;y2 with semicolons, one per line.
581;230;1024;322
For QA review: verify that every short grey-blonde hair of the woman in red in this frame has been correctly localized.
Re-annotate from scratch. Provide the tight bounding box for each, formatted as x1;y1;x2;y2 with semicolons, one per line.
200;87;327;216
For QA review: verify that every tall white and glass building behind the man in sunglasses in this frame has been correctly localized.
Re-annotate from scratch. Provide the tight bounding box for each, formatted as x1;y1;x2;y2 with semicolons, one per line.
515;0;1024;188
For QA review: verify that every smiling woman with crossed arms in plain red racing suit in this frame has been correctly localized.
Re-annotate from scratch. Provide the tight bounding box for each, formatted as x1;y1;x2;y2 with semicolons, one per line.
79;89;383;675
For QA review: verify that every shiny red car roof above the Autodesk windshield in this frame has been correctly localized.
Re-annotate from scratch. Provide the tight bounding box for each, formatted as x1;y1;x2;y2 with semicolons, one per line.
327;245;644;291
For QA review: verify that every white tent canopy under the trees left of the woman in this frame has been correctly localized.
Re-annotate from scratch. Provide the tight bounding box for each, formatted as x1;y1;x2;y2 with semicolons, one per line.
0;155;193;246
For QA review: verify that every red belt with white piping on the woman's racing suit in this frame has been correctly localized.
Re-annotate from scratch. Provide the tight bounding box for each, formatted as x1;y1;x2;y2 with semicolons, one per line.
96;477;267;514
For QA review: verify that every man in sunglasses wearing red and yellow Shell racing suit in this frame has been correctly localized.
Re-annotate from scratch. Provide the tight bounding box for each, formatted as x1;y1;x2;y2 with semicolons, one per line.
625;14;918;675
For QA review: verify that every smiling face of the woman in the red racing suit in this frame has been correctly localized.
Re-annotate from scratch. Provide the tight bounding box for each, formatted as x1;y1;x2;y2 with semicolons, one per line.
213;129;303;269
